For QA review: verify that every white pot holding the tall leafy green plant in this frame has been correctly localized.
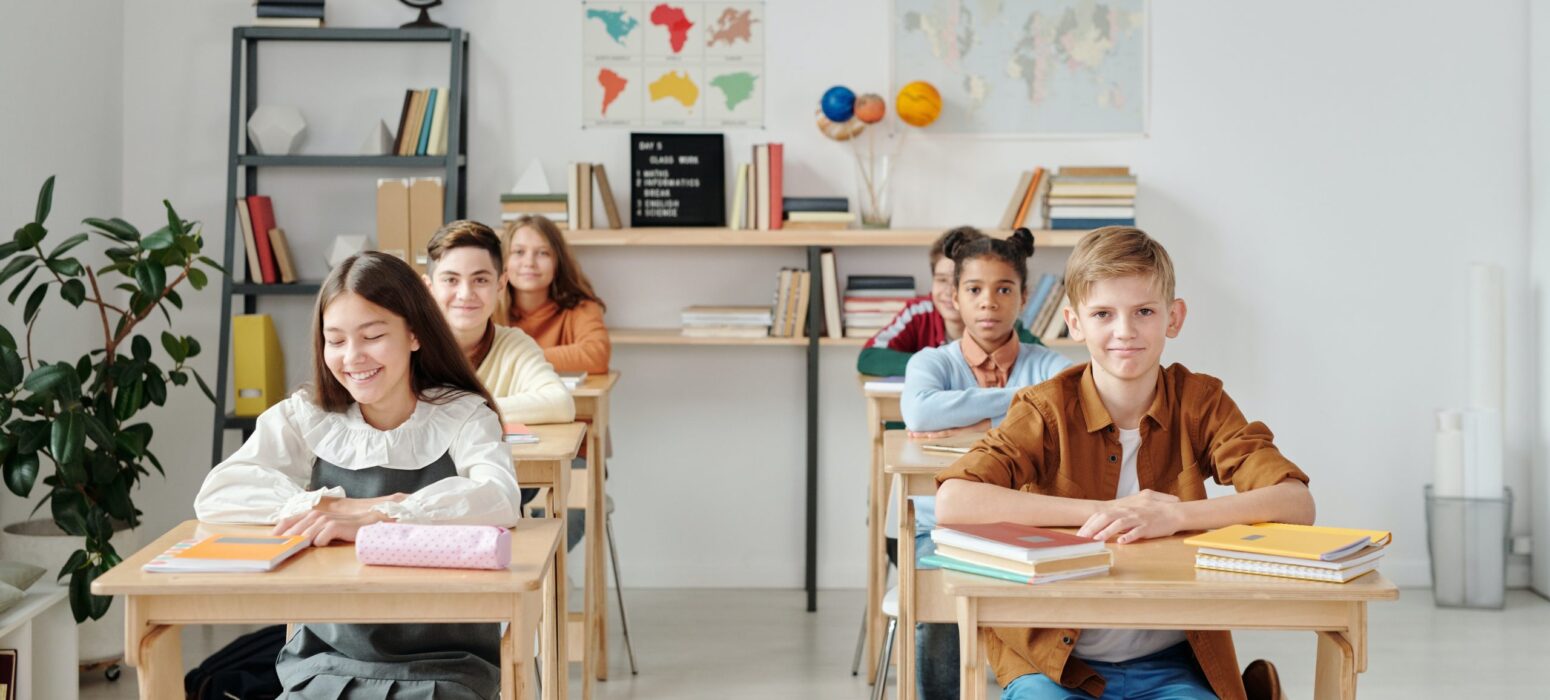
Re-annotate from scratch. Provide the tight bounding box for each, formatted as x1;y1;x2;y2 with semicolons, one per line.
0;519;141;664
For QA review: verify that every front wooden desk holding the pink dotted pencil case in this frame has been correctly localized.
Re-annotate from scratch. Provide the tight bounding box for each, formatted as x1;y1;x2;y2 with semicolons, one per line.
91;520;564;700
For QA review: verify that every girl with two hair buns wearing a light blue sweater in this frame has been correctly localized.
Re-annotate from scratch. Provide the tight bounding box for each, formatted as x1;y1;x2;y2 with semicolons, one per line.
899;229;1071;700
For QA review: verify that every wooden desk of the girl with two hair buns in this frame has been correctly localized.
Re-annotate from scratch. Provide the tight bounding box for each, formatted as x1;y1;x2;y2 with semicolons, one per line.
874;431;959;700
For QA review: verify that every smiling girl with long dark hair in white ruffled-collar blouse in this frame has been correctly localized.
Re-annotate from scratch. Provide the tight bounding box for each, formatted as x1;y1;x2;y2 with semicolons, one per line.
194;252;521;700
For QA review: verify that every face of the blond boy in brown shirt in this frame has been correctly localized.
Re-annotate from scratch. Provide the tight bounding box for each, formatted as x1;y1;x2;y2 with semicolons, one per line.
1065;274;1186;381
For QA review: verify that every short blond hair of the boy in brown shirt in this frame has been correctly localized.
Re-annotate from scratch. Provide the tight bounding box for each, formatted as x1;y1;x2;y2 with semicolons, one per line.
1066;226;1173;307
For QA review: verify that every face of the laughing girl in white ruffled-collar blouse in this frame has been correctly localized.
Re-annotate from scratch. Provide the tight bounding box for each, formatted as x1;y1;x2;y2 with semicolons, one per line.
322;291;420;412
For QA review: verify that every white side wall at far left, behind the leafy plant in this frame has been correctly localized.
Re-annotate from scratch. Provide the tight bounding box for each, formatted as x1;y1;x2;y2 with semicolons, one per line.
0;0;124;523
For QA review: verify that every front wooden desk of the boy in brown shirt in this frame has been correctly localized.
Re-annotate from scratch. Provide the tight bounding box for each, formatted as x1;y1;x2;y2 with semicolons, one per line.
942;534;1400;700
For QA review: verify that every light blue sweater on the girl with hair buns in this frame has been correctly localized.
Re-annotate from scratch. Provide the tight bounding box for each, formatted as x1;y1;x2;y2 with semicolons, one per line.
899;342;1071;431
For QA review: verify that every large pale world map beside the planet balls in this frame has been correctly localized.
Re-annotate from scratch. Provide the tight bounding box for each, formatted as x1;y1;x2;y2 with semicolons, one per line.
891;0;1149;136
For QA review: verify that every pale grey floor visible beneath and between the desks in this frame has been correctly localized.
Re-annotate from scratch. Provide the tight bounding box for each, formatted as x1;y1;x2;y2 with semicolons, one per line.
81;588;1550;700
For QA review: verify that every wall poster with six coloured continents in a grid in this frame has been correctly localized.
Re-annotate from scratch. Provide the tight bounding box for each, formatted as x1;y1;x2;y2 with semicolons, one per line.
581;2;764;129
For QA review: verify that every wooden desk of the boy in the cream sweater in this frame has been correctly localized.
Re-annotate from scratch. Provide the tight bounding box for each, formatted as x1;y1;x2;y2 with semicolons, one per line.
512;423;587;698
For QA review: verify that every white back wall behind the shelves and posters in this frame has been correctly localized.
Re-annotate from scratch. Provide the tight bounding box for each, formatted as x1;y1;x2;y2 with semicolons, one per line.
27;0;1533;587
